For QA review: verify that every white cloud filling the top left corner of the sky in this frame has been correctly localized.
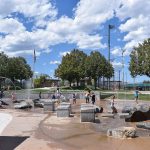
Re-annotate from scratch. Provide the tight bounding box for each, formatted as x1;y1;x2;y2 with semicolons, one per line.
0;0;58;25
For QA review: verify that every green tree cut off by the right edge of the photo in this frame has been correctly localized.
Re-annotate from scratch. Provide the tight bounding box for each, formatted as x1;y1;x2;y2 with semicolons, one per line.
129;38;150;77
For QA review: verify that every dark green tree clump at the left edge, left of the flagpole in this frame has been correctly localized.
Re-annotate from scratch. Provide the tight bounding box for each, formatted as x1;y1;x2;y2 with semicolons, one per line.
0;52;33;88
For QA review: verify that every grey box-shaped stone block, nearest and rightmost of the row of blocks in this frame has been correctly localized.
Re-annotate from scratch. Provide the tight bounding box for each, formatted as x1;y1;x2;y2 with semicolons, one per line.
80;104;95;122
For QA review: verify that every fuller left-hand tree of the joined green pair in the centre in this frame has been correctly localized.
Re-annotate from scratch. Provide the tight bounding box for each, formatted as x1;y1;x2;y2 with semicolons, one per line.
55;49;87;86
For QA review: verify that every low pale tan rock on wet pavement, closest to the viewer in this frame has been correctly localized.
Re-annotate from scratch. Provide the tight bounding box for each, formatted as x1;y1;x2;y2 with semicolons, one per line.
107;127;136;139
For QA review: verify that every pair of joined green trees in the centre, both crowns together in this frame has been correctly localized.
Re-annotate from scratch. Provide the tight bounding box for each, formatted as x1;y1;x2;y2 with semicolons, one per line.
55;49;114;89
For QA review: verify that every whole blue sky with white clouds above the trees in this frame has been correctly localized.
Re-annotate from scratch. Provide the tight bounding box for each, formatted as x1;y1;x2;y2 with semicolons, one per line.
0;0;150;82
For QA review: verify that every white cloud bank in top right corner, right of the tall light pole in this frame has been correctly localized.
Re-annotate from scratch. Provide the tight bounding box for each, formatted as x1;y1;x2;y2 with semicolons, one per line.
117;0;150;52
